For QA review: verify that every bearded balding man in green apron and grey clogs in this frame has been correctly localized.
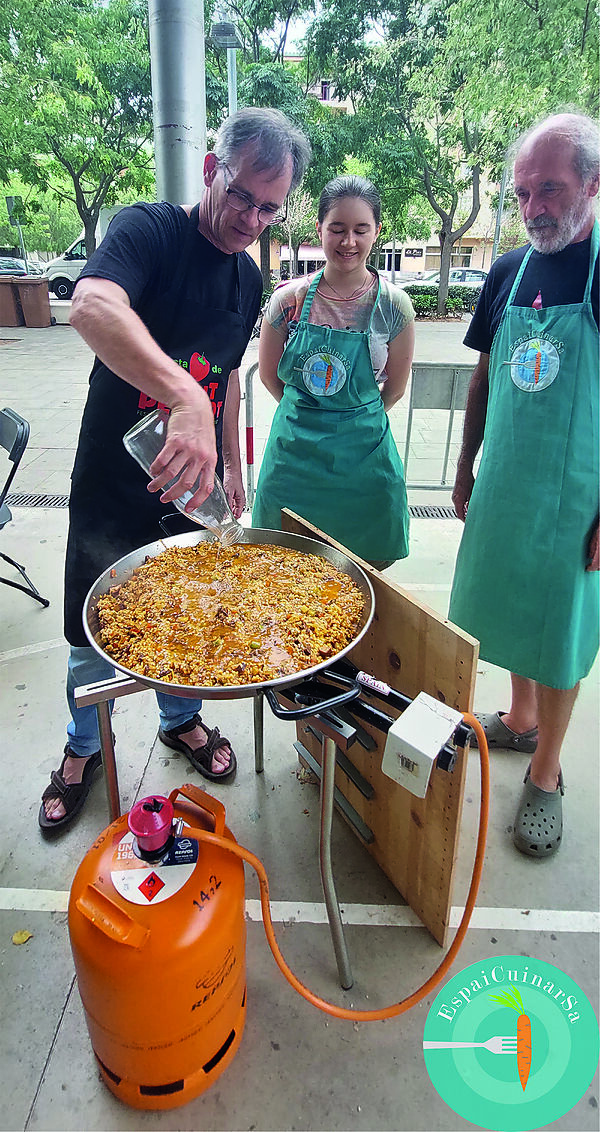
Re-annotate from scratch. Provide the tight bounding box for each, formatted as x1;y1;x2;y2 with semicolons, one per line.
448;113;600;858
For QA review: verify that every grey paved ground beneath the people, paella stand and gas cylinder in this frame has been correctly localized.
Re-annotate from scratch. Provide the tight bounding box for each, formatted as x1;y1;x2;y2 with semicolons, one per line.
0;312;599;1132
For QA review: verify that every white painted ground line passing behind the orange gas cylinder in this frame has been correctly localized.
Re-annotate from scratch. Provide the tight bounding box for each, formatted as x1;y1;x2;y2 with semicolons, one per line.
0;889;600;935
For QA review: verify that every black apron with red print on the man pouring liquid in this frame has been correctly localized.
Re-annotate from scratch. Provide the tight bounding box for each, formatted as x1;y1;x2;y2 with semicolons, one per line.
65;206;248;645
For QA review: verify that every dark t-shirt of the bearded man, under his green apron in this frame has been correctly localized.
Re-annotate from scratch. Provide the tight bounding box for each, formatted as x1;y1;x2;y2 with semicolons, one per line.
463;237;599;354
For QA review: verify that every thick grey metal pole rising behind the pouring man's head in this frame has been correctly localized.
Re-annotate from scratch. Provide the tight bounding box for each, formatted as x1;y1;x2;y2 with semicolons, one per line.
148;0;206;204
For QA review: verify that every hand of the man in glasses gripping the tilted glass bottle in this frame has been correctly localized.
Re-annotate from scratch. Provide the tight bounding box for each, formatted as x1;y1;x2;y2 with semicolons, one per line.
148;386;216;512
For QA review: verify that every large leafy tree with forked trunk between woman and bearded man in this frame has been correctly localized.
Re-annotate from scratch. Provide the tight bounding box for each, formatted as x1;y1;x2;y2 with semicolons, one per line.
307;0;598;314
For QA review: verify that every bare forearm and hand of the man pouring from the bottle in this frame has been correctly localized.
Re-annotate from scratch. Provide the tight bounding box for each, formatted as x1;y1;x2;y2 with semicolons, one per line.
70;276;216;511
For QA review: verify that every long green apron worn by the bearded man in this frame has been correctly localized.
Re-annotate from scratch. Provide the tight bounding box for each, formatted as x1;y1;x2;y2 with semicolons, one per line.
448;223;599;688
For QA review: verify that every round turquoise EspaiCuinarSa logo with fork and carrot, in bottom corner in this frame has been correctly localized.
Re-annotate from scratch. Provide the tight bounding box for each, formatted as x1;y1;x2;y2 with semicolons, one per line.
423;955;600;1132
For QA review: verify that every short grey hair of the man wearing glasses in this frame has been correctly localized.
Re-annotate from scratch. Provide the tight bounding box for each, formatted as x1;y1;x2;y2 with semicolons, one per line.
213;106;312;191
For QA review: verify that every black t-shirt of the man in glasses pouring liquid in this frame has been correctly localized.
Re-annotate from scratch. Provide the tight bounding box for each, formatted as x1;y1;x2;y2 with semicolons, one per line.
79;200;263;377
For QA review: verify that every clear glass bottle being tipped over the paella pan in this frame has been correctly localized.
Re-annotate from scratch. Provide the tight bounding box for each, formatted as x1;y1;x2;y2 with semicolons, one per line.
123;409;243;547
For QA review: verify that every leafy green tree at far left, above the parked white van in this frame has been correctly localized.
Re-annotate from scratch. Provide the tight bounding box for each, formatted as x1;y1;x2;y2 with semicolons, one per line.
0;0;153;255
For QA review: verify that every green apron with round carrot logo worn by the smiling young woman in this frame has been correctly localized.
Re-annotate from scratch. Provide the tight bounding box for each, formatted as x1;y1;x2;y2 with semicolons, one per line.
252;272;409;561
